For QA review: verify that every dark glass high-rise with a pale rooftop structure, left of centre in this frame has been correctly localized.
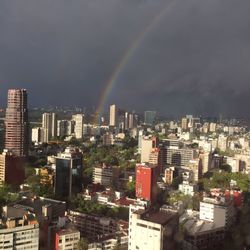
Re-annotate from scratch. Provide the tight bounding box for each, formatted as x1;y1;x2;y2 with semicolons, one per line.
54;148;83;198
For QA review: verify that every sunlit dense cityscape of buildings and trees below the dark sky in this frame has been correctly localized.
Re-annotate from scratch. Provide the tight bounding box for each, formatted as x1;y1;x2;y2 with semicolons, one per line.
0;89;250;250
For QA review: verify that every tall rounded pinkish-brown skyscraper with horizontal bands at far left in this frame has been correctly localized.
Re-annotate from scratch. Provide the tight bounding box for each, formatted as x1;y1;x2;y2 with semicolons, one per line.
5;89;29;156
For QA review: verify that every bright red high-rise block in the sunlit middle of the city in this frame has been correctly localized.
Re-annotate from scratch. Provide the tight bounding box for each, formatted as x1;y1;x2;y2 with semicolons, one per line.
135;164;158;203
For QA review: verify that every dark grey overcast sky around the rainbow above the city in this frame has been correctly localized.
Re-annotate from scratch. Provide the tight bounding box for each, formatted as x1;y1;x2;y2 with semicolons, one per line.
0;0;250;117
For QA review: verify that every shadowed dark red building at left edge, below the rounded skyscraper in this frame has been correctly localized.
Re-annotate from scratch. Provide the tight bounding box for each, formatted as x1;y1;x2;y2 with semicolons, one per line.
0;150;25;186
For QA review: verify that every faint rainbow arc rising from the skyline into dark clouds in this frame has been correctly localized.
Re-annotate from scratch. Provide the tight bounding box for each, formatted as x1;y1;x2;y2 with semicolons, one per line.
95;1;177;123
